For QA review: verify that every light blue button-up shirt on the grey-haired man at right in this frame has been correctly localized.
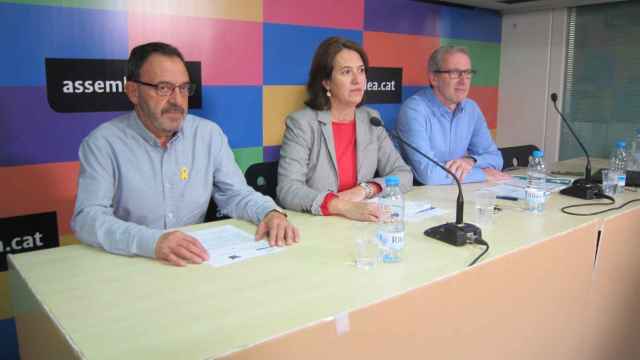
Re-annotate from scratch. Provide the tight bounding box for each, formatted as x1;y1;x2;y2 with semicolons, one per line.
396;87;502;185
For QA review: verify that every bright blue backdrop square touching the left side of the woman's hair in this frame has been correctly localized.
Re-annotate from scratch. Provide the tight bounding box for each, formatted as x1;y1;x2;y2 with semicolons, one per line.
263;23;362;85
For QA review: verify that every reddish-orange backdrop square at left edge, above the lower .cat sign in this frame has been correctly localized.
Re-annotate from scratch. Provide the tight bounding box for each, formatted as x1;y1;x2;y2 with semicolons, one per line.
0;161;80;234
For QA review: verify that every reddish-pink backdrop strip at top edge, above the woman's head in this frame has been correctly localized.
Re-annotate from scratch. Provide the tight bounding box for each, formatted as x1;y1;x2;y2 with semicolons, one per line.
263;0;364;30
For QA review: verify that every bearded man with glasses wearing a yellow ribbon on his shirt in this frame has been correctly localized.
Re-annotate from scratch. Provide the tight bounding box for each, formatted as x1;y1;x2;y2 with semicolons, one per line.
71;43;299;266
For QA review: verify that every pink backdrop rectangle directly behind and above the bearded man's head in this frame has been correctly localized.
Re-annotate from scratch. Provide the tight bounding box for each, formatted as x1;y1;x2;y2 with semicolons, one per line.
129;12;262;85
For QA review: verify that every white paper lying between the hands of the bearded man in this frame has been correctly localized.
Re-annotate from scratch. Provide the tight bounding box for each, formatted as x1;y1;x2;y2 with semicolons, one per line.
187;225;284;267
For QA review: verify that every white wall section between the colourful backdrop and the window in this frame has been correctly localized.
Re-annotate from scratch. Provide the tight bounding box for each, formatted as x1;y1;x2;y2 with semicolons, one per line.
496;9;567;161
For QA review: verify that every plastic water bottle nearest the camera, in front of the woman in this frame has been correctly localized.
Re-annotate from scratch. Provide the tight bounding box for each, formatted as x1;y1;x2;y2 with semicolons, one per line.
378;176;405;263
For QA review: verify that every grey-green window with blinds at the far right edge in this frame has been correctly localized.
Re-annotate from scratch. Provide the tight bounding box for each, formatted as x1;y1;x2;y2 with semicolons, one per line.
560;2;640;160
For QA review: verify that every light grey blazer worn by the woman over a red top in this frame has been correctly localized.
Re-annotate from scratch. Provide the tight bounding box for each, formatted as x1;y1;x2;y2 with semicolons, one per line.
277;107;413;215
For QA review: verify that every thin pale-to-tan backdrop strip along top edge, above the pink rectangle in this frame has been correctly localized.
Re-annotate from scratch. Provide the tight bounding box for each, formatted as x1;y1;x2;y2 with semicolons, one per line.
129;0;262;22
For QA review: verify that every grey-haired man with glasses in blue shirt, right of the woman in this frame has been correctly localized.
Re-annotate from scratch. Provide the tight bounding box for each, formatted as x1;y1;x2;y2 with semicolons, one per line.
396;46;509;184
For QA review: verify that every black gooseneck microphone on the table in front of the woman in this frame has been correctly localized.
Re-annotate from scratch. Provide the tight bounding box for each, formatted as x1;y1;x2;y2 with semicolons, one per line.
369;117;485;246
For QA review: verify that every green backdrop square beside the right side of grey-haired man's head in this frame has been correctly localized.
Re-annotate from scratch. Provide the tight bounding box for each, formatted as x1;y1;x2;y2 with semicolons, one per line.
440;38;500;87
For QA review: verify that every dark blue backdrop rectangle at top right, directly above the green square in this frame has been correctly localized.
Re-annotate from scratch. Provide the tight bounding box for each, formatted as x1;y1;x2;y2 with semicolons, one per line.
438;6;502;43
